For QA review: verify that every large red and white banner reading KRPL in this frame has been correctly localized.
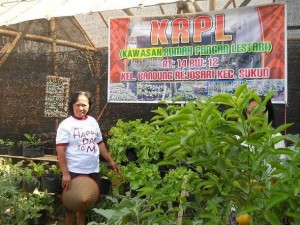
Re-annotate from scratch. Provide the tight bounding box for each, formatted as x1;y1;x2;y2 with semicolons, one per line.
108;4;287;103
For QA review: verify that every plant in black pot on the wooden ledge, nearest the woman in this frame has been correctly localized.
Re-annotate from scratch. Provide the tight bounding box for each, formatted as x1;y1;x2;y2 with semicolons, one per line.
23;133;45;158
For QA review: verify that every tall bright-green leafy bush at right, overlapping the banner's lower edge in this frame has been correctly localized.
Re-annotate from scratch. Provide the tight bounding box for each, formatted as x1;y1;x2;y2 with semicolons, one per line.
152;84;299;224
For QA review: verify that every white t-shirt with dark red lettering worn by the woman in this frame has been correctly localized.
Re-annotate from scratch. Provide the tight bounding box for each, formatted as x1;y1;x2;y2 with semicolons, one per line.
56;116;103;174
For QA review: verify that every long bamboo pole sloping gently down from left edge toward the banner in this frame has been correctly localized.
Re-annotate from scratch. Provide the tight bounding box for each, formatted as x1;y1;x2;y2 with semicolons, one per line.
0;29;97;51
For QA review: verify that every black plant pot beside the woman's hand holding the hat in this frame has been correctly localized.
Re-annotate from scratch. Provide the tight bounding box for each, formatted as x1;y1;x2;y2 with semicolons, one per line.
42;173;62;194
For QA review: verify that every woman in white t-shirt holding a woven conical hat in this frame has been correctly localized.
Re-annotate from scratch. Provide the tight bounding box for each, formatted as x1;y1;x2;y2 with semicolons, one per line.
56;91;120;225
